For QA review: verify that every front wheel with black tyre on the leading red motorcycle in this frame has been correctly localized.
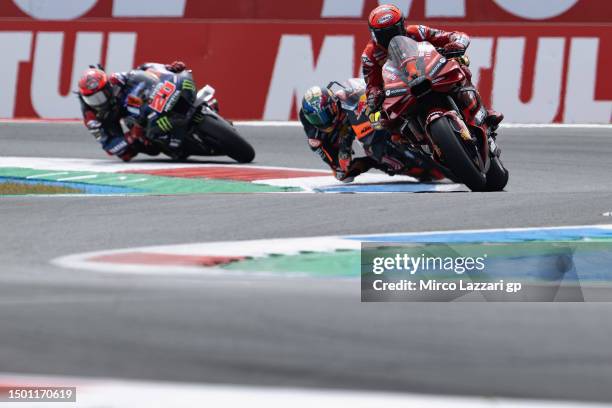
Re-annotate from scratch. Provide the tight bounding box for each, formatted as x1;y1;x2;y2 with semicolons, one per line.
430;117;487;191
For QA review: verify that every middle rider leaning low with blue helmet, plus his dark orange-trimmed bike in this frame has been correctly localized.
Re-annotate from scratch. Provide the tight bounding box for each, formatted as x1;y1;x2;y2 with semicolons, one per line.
299;78;442;183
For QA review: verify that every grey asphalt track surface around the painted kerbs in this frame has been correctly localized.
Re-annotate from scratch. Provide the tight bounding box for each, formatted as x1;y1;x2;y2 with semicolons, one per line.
0;124;612;402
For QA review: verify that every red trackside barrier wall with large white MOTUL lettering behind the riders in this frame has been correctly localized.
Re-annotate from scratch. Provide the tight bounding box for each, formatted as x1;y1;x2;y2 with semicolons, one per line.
0;0;612;123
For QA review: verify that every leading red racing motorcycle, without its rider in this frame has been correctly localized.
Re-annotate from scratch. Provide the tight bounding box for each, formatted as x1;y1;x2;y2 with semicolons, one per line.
383;36;509;191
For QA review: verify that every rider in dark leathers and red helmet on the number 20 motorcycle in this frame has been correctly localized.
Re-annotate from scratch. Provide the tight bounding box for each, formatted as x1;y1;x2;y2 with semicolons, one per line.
78;61;190;161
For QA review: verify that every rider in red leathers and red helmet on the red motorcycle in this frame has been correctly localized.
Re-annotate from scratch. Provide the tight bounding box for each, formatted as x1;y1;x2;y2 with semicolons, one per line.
361;4;504;128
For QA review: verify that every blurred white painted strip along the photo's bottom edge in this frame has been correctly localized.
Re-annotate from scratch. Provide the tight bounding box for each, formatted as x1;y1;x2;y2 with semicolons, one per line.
0;373;610;408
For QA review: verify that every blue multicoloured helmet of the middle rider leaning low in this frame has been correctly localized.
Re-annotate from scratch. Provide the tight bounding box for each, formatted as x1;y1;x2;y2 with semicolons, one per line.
302;86;342;132
